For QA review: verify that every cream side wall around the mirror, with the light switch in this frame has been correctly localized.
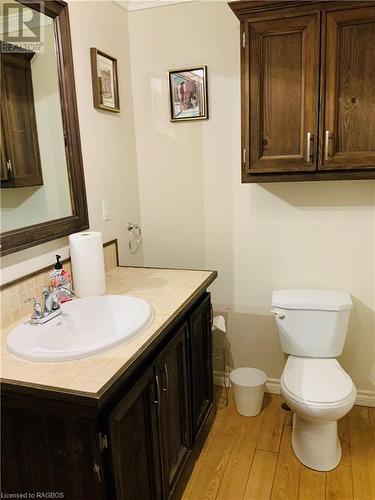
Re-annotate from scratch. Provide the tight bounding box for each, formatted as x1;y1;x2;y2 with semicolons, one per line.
2;0;143;282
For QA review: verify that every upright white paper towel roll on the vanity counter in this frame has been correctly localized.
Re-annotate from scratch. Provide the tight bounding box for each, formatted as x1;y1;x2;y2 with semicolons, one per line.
69;231;105;297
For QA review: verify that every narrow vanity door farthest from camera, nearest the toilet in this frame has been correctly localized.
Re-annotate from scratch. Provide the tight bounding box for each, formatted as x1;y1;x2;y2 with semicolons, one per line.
189;293;213;442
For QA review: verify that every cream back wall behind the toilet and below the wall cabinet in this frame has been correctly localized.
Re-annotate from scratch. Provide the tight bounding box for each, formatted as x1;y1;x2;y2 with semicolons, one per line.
129;1;375;390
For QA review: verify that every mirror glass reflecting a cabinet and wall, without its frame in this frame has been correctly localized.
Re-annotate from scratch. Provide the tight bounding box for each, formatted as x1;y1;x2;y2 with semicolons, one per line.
1;1;73;233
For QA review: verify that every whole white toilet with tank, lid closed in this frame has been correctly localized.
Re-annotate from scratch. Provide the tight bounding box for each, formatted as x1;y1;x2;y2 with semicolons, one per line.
271;290;357;471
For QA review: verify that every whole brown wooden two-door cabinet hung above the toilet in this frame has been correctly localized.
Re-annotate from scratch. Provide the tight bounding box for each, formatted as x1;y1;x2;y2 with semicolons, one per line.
230;1;375;182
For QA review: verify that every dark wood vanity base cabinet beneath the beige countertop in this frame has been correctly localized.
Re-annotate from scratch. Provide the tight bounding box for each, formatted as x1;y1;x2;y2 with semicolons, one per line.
2;280;216;500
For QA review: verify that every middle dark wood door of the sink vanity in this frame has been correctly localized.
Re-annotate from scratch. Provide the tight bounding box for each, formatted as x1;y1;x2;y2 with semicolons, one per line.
158;323;190;498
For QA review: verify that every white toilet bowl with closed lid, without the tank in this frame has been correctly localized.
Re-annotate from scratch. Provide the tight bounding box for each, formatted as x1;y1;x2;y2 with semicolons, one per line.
281;356;356;471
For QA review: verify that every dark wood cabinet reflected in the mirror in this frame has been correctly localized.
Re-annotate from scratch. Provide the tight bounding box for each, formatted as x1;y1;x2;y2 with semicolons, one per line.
1;52;43;187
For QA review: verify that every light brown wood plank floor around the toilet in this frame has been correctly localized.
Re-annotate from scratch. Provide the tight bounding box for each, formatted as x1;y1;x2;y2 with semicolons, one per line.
183;394;375;500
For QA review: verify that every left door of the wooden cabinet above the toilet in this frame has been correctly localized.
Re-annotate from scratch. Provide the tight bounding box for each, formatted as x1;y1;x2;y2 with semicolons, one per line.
242;13;320;175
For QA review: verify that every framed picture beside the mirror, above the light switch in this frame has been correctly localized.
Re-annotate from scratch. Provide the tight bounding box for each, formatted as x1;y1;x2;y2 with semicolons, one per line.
90;47;120;113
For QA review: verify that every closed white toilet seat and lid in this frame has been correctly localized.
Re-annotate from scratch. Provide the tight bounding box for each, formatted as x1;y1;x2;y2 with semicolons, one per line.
281;356;355;407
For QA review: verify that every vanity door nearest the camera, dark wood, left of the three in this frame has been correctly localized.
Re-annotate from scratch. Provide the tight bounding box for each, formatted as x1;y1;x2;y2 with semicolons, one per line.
109;367;162;500
